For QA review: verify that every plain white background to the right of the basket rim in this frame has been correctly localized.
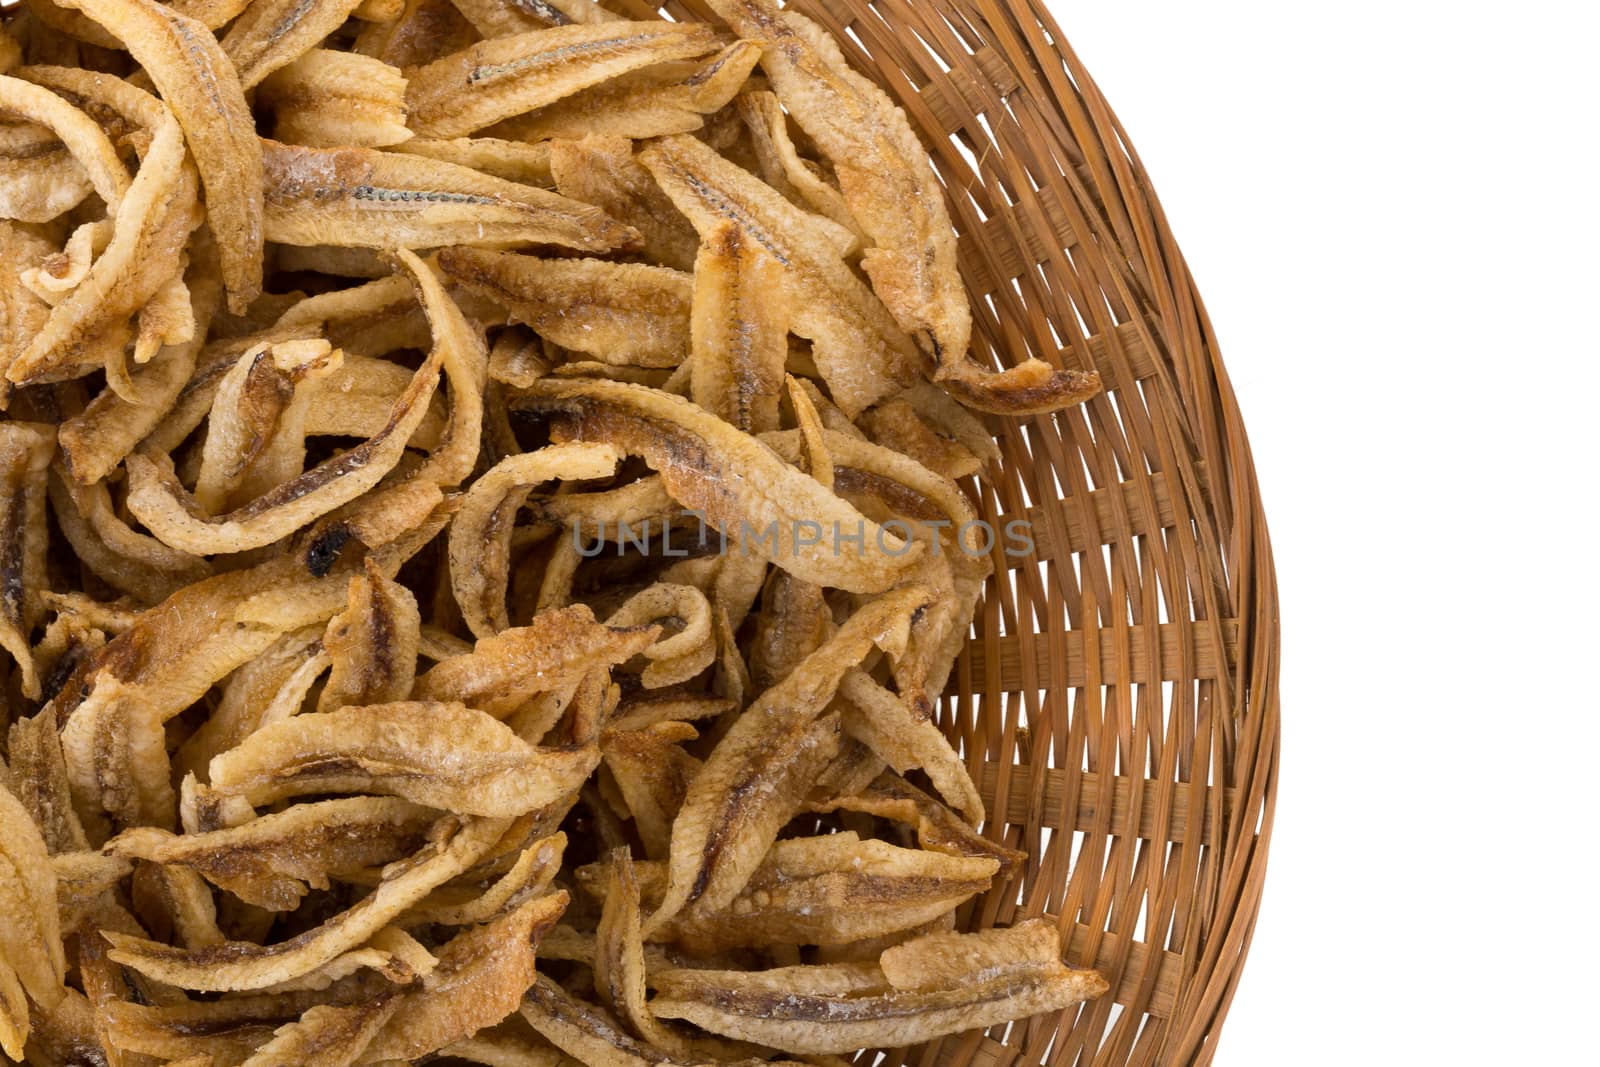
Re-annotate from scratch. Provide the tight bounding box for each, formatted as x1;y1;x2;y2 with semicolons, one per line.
1053;0;1600;1067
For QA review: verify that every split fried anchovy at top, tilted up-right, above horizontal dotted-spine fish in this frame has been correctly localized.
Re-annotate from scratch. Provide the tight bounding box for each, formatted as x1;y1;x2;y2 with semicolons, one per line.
406;21;718;138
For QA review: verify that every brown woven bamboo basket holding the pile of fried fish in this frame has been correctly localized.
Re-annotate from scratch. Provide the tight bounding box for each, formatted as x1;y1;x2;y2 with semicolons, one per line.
634;0;1278;1067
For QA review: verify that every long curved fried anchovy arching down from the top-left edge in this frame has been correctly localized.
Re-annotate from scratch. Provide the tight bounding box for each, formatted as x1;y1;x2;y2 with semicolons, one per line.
53;0;264;315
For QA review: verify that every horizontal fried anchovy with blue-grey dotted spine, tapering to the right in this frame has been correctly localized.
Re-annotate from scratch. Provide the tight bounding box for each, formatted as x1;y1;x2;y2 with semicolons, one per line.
262;141;637;251
